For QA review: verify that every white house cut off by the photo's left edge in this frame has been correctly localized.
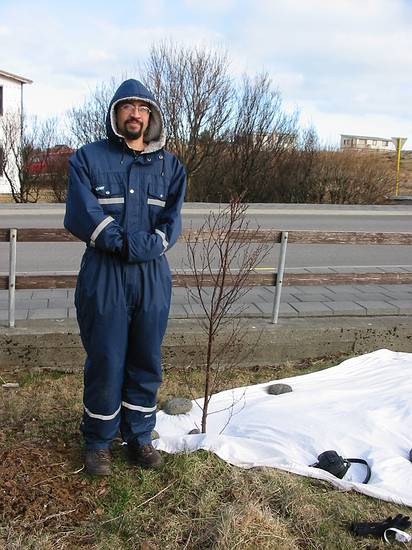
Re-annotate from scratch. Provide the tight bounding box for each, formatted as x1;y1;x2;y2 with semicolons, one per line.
0;69;32;193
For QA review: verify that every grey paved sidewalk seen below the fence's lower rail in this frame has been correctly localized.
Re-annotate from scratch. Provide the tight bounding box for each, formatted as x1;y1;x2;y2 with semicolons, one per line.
0;284;412;326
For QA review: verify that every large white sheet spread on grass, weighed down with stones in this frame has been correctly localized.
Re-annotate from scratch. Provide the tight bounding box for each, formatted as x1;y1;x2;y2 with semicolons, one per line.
156;350;412;506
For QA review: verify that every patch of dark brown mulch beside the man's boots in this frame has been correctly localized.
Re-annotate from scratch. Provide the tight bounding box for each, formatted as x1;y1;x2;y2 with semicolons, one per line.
0;442;112;548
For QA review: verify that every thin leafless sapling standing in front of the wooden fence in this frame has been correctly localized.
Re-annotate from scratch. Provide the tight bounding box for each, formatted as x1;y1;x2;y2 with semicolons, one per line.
186;199;270;432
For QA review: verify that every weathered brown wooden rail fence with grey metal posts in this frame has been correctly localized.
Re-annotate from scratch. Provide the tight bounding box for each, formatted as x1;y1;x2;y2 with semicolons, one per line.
0;228;412;327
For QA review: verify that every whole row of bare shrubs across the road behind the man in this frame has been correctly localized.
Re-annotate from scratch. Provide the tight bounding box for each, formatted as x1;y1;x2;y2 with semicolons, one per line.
64;41;391;204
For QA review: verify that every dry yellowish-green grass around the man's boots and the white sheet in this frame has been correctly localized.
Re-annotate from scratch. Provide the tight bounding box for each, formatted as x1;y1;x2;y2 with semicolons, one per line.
0;359;408;550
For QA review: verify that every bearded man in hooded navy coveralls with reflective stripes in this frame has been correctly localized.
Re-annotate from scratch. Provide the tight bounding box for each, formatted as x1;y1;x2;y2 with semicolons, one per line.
64;79;186;475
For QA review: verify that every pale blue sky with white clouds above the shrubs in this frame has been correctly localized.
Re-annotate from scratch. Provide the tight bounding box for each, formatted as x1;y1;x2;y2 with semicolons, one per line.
0;0;412;149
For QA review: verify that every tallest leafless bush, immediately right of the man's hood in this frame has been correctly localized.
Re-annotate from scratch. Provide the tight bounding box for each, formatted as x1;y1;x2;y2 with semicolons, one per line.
144;42;233;198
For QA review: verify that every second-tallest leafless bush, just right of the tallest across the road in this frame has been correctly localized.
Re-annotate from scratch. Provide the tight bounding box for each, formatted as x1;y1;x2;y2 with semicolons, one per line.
193;73;299;202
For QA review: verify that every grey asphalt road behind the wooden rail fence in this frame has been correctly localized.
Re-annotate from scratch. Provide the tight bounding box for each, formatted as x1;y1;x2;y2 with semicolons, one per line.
0;204;412;272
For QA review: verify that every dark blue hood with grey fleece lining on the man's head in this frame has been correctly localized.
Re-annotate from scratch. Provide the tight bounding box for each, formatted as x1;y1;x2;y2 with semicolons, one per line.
106;78;166;153
